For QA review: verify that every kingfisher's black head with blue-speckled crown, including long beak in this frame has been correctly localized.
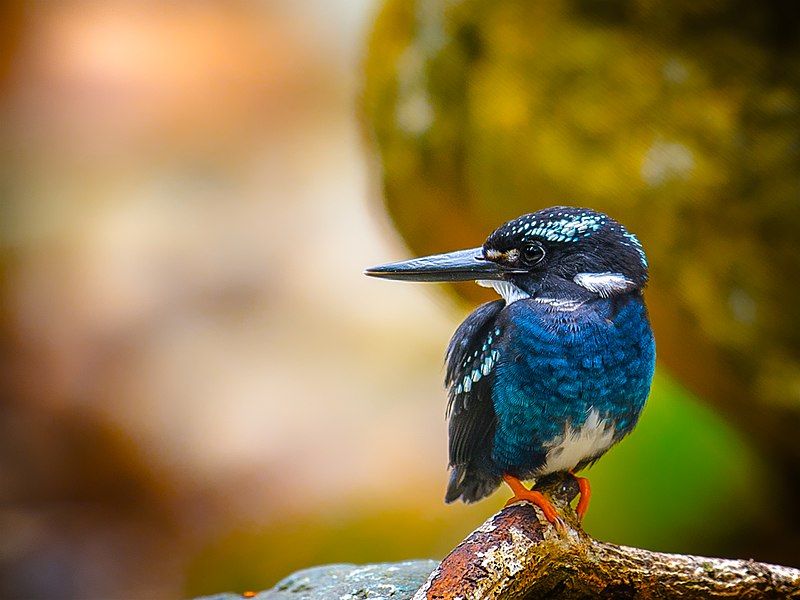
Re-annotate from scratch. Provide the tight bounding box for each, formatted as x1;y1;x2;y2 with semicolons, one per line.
365;206;647;302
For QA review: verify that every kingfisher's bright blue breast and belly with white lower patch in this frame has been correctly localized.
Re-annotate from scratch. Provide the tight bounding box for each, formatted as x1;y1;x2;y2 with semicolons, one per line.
493;296;655;473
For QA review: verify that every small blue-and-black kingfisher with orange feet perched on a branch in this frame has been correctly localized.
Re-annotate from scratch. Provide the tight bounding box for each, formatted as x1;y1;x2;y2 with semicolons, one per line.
365;206;656;524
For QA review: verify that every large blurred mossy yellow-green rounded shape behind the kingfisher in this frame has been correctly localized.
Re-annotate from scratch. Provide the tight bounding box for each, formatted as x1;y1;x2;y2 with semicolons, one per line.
363;0;800;434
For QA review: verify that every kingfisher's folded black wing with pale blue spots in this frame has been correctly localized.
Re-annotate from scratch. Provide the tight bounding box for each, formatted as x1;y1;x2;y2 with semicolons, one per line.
445;299;505;502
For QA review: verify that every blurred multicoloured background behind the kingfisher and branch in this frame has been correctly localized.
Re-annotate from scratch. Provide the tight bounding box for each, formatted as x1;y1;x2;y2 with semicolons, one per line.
0;0;800;598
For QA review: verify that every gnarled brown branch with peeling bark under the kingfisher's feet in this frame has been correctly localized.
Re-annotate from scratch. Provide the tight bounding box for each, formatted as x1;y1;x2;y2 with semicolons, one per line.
414;475;800;600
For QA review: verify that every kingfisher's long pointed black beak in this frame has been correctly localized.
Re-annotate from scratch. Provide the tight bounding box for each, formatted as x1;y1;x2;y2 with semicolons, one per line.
364;248;525;281
